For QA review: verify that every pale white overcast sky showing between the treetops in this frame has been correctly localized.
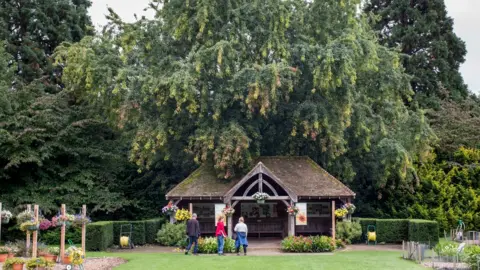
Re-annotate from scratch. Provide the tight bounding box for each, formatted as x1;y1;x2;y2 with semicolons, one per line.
90;0;480;94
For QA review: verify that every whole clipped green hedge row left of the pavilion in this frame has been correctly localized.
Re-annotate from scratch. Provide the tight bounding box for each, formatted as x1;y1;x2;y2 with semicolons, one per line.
86;218;165;251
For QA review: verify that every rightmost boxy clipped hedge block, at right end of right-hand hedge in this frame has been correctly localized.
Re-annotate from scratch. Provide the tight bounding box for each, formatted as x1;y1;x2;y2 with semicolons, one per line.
408;219;439;246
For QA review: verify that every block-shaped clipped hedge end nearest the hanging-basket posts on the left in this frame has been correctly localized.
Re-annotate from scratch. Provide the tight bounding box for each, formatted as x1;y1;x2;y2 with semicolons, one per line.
85;221;113;251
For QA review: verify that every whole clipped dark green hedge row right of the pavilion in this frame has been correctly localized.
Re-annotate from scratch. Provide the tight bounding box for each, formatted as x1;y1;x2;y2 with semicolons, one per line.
354;218;439;245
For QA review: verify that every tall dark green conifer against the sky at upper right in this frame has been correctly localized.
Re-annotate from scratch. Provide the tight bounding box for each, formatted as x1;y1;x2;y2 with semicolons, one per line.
365;0;468;104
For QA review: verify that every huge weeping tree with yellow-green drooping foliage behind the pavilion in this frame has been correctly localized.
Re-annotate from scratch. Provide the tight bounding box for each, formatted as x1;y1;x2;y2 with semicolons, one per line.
56;0;434;211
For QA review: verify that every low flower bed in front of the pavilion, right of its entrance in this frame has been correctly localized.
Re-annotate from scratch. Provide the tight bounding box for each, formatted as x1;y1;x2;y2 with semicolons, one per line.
281;236;336;252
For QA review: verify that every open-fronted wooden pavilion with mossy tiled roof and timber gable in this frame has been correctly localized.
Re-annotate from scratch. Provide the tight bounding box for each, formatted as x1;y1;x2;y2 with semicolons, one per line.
166;157;355;240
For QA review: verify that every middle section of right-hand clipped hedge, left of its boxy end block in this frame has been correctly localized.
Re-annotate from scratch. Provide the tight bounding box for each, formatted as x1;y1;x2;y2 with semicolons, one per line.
376;219;408;243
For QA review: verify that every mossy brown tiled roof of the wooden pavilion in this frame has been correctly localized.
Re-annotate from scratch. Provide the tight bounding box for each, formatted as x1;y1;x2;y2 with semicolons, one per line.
166;157;355;199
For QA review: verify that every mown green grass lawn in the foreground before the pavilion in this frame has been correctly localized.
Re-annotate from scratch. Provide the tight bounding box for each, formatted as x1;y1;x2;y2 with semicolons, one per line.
87;251;425;270
